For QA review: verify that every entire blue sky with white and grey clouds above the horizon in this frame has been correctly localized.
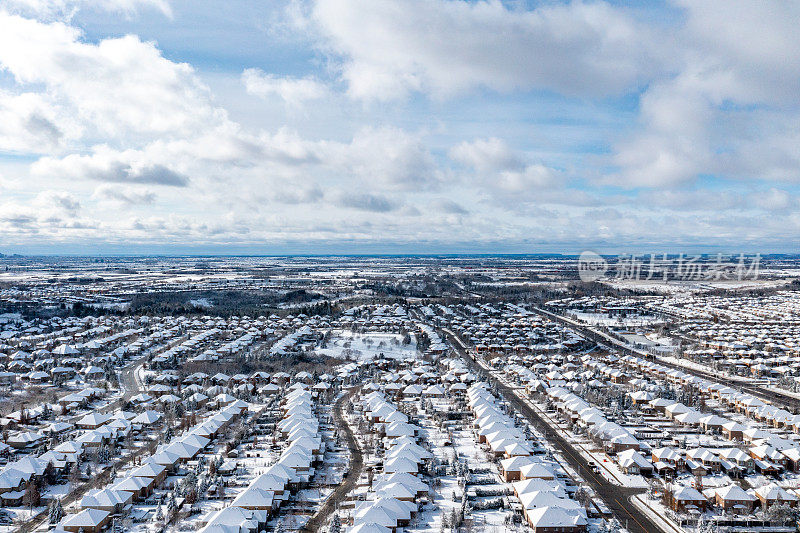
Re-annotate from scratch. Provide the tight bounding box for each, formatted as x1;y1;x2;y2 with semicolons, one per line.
0;0;800;253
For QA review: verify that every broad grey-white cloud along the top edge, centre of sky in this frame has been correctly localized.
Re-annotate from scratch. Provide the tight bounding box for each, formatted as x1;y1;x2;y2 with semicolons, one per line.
310;0;656;100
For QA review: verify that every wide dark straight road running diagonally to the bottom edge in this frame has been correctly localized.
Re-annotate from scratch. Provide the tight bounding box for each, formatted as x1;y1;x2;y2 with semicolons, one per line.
444;330;662;533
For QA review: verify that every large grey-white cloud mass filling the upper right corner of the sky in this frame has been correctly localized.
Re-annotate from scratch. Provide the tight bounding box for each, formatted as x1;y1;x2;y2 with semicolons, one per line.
607;1;800;187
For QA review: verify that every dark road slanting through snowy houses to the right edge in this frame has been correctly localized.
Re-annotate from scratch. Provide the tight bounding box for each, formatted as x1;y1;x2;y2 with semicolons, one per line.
533;307;800;413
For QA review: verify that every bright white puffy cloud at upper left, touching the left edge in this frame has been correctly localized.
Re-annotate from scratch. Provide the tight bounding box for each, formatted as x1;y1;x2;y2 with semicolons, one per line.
0;10;216;142
